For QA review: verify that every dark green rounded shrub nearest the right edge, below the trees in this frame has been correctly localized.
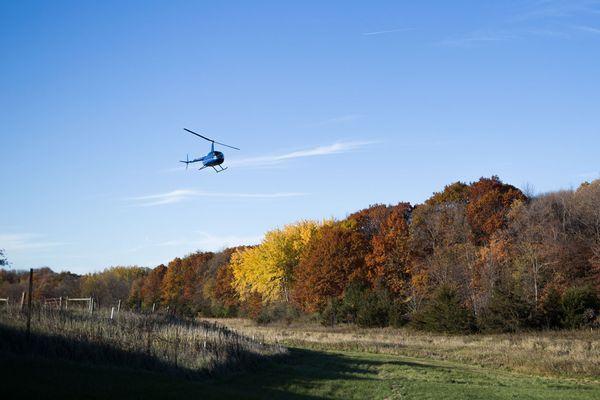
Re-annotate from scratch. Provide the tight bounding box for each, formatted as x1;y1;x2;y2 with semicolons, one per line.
561;286;599;329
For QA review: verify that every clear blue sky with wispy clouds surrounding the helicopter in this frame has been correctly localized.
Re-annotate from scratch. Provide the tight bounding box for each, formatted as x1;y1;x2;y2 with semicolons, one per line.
0;0;600;273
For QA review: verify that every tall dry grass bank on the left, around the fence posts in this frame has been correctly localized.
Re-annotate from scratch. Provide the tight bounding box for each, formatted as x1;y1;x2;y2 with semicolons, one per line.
0;308;287;375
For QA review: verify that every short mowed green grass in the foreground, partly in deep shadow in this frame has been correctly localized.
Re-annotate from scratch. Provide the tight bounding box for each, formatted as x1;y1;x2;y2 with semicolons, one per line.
0;349;600;400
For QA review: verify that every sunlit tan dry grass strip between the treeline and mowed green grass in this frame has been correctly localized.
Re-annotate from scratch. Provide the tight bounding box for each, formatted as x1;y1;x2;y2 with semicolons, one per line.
211;319;600;381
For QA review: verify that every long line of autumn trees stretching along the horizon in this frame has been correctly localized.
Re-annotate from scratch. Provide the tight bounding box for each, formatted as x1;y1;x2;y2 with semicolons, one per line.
0;176;600;332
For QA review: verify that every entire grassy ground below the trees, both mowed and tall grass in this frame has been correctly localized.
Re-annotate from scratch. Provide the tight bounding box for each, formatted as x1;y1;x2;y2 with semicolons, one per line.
0;313;600;400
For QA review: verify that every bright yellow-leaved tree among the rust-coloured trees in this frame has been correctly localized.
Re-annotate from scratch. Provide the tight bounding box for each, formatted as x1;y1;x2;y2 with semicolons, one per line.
230;221;326;302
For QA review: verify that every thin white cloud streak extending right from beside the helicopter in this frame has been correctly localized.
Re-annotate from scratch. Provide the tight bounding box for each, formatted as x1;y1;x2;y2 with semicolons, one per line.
231;141;376;166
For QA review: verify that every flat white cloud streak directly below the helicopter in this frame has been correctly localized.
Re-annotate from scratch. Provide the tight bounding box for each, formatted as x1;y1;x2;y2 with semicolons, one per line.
125;189;306;207
